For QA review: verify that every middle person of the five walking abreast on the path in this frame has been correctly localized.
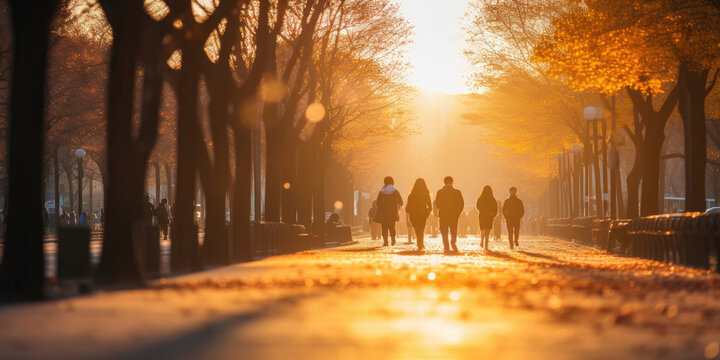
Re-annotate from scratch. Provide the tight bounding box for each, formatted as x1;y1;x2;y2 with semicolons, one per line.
435;176;465;252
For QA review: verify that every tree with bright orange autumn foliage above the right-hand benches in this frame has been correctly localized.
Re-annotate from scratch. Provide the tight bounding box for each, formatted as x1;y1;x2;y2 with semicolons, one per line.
536;0;715;215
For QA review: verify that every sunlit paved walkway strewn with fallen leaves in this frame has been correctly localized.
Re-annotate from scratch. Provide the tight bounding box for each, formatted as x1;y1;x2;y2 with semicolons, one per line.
0;238;720;359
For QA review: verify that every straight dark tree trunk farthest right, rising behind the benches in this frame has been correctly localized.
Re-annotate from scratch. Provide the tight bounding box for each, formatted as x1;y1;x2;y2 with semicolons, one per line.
679;64;709;211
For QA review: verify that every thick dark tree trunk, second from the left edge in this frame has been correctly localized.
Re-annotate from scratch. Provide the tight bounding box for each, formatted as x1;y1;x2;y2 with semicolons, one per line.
96;2;145;284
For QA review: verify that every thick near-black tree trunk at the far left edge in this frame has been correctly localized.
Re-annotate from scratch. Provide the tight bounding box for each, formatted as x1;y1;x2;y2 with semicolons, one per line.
0;0;57;301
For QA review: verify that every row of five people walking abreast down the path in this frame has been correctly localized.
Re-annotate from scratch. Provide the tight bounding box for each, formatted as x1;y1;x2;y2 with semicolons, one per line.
370;176;525;252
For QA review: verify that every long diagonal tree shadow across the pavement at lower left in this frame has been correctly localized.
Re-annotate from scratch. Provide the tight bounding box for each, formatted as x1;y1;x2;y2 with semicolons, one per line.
98;295;312;360
